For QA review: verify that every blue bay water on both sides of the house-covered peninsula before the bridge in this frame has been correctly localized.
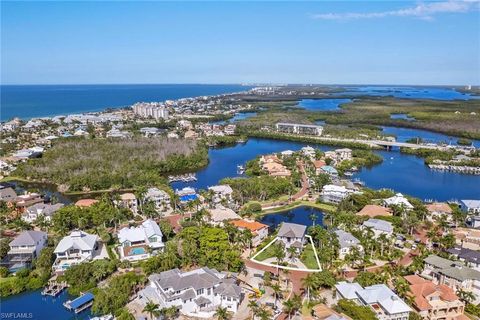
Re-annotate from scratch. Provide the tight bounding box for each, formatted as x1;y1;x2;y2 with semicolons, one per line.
172;138;480;201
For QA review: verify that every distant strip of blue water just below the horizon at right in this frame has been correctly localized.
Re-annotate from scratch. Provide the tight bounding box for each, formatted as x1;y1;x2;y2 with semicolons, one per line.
332;86;480;100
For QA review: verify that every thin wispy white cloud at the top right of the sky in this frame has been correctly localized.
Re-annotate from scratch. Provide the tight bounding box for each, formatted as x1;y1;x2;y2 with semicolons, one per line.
313;0;480;20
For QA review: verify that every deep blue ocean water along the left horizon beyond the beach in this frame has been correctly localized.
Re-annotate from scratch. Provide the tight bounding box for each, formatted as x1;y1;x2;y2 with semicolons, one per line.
0;84;251;121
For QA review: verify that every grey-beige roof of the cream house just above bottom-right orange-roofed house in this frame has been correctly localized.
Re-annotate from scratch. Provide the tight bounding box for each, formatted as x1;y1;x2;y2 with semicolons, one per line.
424;255;480;281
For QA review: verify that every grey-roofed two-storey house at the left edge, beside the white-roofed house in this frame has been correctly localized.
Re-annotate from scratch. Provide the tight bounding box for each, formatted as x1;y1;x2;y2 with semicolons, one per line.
0;230;47;273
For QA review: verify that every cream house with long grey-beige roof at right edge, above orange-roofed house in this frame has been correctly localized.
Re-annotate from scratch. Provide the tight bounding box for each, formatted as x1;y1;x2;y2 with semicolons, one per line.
422;255;480;303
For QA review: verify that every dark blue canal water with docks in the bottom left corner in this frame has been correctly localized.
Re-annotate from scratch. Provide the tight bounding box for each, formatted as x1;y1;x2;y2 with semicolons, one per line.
1;290;92;320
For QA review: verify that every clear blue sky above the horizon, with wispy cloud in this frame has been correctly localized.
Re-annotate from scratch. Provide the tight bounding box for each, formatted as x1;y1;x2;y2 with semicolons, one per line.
1;0;480;84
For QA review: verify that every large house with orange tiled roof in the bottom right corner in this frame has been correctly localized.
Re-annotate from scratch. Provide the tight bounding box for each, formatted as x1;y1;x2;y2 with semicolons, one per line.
404;275;467;320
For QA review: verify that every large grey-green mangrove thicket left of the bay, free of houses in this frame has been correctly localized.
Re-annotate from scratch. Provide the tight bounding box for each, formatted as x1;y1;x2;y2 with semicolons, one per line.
15;137;208;191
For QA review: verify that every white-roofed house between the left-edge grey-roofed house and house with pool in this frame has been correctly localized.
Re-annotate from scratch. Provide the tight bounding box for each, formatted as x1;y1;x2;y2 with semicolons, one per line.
53;230;99;272
